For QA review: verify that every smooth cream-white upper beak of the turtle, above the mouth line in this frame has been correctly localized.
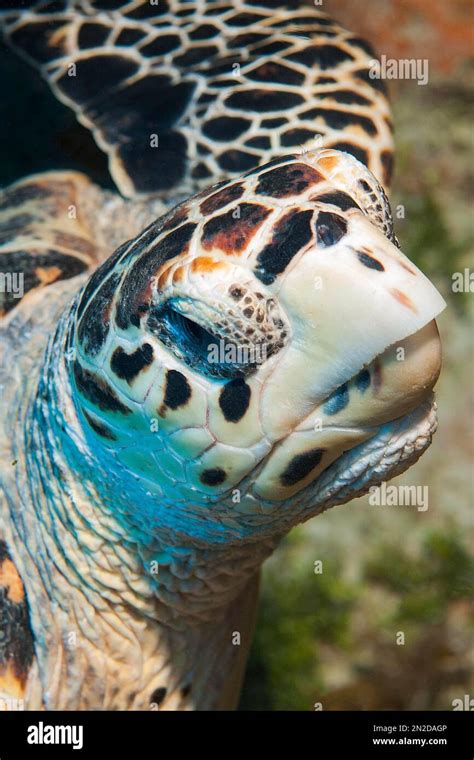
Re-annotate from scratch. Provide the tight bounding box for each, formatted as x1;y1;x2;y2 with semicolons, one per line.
261;213;446;439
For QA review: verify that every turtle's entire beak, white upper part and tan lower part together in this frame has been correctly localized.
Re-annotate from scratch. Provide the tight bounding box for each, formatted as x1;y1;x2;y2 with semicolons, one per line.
250;214;445;501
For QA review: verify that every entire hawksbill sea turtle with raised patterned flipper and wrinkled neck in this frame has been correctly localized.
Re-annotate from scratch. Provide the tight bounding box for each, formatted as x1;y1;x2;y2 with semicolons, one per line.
0;0;444;709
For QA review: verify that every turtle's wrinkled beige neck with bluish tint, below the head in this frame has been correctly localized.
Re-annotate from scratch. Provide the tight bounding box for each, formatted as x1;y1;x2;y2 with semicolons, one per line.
5;294;277;709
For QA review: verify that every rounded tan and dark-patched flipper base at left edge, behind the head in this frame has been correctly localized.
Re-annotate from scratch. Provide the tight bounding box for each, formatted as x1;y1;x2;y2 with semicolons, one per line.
0;172;105;317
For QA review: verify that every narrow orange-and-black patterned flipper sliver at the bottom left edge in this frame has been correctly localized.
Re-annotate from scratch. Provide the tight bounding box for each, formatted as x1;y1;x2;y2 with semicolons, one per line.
0;538;34;711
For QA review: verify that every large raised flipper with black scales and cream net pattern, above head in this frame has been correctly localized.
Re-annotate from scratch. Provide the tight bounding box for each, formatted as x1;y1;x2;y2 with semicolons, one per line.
0;0;393;199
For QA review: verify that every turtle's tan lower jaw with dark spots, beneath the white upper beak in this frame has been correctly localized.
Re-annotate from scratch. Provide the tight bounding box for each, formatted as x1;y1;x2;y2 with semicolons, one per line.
254;320;441;502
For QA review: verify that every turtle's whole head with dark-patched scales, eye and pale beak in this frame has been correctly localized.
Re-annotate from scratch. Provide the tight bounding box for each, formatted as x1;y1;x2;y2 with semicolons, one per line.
72;149;444;534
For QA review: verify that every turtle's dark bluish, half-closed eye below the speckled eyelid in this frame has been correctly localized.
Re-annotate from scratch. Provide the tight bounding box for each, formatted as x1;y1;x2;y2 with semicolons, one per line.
147;301;255;378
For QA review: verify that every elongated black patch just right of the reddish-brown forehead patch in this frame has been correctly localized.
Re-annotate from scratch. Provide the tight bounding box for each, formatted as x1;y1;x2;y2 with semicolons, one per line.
255;211;313;285
